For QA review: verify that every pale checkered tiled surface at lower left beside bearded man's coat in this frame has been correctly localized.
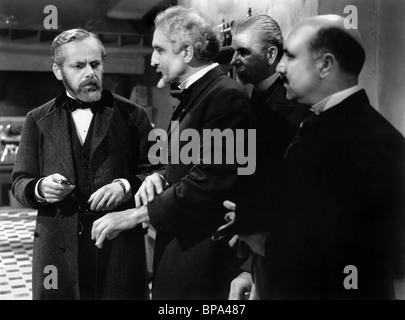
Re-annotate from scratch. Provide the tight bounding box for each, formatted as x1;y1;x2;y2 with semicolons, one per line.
0;207;36;300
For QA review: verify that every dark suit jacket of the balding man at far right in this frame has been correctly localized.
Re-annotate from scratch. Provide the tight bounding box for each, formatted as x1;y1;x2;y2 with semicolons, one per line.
252;90;405;299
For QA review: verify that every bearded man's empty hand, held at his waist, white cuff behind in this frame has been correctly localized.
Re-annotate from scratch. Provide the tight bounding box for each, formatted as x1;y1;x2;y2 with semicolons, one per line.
87;182;129;211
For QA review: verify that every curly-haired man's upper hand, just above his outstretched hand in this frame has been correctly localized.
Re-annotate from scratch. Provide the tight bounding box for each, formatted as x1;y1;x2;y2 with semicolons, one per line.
135;172;169;208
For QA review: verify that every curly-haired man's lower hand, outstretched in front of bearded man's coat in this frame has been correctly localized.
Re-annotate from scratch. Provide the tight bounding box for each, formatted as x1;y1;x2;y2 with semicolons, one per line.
91;207;149;249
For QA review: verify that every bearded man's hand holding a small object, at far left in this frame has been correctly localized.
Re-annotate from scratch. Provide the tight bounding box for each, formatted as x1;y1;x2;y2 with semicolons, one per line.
38;173;75;203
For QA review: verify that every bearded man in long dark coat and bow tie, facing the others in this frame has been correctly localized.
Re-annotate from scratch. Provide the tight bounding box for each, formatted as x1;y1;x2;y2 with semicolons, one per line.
12;29;152;300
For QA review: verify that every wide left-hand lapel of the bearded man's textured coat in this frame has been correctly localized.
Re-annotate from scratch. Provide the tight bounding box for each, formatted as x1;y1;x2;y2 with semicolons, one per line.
38;94;75;181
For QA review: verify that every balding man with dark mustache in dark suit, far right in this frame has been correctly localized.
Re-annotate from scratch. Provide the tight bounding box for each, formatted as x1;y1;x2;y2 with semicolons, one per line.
230;14;405;300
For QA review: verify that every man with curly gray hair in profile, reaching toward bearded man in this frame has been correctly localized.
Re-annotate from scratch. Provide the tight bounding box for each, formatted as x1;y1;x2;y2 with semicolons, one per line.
94;6;249;300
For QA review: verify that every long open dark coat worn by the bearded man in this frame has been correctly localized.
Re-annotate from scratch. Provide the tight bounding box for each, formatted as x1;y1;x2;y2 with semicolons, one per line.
12;91;151;299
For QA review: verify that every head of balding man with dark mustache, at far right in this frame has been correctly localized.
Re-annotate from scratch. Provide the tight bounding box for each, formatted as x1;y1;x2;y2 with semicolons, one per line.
277;15;365;105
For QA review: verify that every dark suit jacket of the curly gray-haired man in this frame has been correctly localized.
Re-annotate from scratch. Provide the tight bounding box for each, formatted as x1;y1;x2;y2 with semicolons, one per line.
148;67;250;299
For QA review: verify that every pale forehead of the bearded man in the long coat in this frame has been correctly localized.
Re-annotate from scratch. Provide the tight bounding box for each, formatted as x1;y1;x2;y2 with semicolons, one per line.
61;38;102;62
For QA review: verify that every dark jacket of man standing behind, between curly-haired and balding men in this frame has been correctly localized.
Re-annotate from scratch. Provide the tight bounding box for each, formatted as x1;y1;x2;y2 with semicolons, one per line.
235;78;311;296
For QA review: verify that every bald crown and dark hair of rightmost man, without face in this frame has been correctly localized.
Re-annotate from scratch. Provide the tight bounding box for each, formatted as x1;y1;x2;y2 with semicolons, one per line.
291;14;366;76
